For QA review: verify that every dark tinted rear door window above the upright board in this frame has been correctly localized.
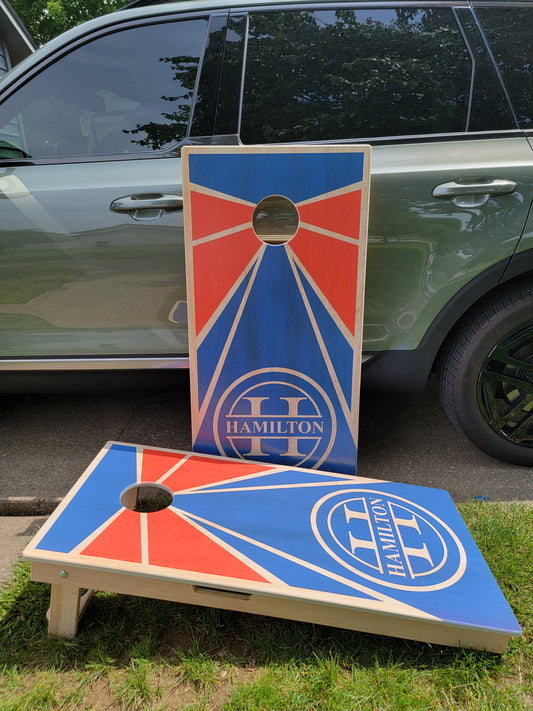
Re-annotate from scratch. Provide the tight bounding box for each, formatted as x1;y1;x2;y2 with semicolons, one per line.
241;8;472;143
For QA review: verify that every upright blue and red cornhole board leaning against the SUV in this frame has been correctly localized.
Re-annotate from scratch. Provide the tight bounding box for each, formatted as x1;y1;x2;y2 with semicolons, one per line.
182;145;370;474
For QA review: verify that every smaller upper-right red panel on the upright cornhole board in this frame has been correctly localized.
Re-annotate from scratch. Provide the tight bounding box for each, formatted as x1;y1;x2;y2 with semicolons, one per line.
297;190;361;239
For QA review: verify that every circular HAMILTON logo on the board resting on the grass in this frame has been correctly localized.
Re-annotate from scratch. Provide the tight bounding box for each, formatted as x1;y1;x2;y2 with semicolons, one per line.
311;489;466;592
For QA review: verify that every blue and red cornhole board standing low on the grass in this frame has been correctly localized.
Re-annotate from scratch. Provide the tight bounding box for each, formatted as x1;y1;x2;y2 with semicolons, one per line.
24;443;520;652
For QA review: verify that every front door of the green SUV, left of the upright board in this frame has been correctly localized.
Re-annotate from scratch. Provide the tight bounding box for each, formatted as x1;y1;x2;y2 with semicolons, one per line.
0;13;218;367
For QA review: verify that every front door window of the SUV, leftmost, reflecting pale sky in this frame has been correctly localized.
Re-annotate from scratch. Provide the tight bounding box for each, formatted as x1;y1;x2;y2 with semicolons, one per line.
0;18;207;158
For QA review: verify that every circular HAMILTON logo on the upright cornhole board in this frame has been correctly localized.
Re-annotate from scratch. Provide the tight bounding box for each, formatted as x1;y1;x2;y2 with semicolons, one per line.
213;368;337;467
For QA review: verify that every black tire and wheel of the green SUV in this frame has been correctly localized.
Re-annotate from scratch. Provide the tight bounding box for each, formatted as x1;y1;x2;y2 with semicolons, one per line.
437;278;533;466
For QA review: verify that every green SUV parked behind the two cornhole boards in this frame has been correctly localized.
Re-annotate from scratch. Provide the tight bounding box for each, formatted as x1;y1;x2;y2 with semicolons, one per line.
0;0;533;465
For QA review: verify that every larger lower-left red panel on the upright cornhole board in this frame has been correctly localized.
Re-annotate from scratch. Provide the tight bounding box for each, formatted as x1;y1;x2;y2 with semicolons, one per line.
193;228;261;335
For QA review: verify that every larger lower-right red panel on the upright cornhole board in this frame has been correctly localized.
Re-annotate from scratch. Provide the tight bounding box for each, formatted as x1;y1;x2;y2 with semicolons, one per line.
290;228;359;334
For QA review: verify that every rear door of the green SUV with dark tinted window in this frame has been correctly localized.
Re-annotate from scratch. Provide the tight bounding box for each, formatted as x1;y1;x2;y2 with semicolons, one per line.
234;3;533;384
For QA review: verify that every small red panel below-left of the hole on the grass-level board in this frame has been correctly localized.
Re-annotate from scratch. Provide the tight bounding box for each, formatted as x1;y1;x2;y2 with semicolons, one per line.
81;509;142;563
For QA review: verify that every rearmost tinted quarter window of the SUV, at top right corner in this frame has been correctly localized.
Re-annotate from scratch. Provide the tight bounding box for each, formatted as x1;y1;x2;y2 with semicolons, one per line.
476;7;533;128
